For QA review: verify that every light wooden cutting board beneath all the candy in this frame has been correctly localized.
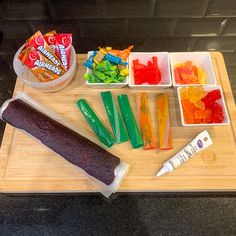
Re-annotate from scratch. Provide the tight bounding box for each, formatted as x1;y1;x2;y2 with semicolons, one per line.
0;52;236;192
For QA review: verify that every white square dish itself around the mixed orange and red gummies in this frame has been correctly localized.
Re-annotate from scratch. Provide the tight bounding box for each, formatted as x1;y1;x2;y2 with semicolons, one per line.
177;85;230;126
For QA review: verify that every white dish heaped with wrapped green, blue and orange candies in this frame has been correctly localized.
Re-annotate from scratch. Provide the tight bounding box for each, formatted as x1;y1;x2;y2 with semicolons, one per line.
83;46;133;88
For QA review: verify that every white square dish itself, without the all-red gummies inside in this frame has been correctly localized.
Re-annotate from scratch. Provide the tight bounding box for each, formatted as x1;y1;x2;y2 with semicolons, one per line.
129;52;172;89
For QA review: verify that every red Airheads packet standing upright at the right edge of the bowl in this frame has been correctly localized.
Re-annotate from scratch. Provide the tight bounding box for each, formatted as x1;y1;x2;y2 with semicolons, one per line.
55;34;72;70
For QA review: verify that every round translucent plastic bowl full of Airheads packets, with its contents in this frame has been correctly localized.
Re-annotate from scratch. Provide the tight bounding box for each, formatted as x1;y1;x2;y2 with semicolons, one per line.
13;31;76;92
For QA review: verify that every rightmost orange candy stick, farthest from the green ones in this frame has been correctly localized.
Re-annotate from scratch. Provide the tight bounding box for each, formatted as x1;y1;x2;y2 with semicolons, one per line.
156;93;173;150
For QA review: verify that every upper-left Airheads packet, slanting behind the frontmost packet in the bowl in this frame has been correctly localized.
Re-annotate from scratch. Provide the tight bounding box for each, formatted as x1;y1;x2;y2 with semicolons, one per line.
22;31;65;70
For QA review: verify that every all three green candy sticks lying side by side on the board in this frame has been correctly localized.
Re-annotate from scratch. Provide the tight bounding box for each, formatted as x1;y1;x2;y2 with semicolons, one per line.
77;91;143;148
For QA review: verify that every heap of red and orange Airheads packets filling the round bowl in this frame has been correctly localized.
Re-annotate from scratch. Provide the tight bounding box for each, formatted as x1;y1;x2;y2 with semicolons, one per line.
18;30;72;82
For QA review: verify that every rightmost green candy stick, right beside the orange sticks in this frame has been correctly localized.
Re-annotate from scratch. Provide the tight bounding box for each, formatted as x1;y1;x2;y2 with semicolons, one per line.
117;94;143;148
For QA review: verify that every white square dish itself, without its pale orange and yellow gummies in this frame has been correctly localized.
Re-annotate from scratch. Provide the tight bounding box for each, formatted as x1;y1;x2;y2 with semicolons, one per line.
170;52;216;87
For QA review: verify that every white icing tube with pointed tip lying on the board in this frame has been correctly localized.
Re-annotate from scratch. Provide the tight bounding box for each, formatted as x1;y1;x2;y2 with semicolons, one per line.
156;130;213;176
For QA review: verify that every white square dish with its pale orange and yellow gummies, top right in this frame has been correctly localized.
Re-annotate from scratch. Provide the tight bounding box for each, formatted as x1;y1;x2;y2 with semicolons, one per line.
170;52;216;87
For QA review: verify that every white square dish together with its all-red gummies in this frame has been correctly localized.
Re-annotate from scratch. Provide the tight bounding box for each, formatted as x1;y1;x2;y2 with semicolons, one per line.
129;52;172;89
